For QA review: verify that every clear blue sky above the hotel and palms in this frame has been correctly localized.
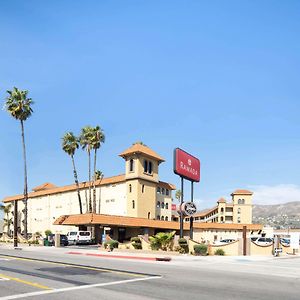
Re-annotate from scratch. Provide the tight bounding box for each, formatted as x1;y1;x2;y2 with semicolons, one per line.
0;0;300;216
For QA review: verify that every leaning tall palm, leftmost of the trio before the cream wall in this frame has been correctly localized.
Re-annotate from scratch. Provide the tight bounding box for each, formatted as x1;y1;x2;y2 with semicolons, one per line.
62;132;82;214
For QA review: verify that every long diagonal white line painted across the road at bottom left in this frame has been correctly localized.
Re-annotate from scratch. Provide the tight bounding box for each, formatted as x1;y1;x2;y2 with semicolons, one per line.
0;276;162;300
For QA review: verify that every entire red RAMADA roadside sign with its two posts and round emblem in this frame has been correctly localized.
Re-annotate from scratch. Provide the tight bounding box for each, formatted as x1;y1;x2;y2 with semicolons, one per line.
173;148;200;239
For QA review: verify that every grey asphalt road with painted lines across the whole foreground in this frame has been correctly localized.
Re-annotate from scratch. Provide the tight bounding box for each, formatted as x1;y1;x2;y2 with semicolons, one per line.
0;248;300;300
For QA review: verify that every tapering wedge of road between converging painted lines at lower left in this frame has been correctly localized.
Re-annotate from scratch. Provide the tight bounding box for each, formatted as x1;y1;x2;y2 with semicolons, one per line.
0;257;155;297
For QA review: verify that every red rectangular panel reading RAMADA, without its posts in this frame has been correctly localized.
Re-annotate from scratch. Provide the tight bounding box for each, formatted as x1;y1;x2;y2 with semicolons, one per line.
174;148;200;182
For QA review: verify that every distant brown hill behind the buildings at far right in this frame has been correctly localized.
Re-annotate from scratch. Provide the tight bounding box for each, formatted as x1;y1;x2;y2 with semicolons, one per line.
252;201;300;218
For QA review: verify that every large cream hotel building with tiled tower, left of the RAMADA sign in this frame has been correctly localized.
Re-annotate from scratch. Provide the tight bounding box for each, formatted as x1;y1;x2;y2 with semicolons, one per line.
3;144;175;233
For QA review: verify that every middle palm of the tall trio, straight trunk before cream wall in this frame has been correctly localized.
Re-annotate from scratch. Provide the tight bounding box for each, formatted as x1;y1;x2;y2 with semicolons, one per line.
79;126;94;213
